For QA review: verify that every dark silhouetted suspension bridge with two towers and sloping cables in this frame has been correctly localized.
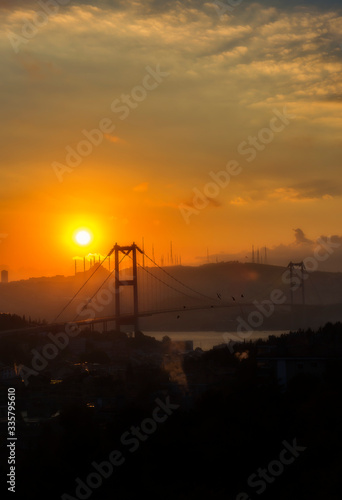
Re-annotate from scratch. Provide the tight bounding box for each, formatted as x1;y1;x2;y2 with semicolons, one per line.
2;243;320;334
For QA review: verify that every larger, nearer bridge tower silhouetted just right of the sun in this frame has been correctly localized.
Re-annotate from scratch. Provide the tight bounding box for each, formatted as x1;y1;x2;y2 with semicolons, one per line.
113;243;143;334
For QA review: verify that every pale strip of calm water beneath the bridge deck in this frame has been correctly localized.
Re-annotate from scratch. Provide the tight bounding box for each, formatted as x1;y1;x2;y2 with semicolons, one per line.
144;330;288;351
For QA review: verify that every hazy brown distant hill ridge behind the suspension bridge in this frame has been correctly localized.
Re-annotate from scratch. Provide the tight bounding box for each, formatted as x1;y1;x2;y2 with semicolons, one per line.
0;262;342;331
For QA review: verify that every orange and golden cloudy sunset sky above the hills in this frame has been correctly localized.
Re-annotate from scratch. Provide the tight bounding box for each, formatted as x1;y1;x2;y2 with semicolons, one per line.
0;0;342;279
